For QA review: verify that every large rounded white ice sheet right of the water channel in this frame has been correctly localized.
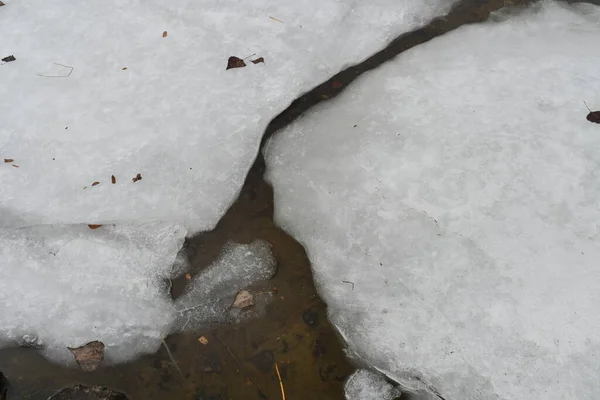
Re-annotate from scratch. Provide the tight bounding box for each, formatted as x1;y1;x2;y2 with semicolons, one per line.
267;1;600;400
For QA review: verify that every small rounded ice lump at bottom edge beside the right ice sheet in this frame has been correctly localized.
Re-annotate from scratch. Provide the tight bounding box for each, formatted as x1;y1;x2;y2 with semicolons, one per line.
344;369;401;400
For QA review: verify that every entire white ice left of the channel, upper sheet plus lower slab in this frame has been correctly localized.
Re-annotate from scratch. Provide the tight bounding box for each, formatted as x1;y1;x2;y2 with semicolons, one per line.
0;0;453;361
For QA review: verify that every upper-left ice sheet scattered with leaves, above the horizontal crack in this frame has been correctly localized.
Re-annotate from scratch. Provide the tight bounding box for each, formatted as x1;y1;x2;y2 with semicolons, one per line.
0;0;453;231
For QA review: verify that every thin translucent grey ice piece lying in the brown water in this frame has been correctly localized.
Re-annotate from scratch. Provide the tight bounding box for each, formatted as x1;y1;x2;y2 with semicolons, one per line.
176;240;276;329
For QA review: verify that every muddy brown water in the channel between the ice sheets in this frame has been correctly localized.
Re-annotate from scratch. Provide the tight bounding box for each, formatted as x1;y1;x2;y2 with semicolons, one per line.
0;0;548;400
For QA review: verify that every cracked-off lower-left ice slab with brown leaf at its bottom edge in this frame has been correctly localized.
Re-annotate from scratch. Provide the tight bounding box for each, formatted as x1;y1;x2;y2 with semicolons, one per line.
0;223;185;363
